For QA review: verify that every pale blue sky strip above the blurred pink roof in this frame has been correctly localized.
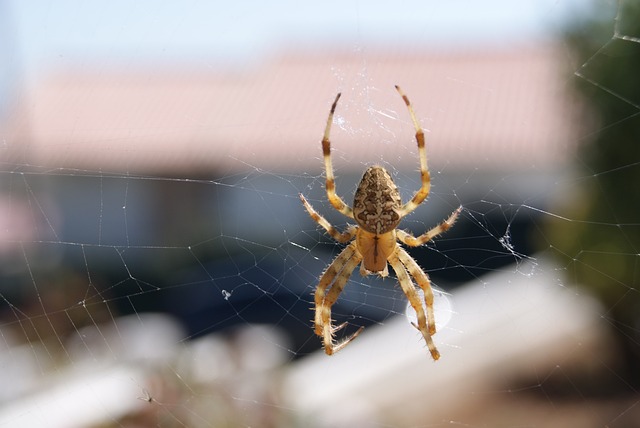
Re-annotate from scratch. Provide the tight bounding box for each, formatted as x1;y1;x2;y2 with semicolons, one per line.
2;0;576;68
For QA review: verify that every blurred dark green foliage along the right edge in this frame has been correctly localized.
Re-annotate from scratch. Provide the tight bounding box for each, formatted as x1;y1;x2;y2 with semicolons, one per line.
547;0;640;381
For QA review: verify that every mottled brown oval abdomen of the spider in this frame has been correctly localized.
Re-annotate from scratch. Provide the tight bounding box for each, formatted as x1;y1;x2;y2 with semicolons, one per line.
353;166;402;235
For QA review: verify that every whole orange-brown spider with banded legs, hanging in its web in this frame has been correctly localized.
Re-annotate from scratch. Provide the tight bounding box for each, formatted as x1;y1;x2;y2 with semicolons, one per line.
300;85;462;360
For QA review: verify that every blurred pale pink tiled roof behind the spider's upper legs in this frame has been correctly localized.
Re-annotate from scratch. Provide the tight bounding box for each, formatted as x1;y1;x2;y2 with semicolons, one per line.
0;46;577;173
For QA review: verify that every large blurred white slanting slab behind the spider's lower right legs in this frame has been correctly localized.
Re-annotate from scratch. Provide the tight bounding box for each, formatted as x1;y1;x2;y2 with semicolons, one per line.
285;262;606;426
